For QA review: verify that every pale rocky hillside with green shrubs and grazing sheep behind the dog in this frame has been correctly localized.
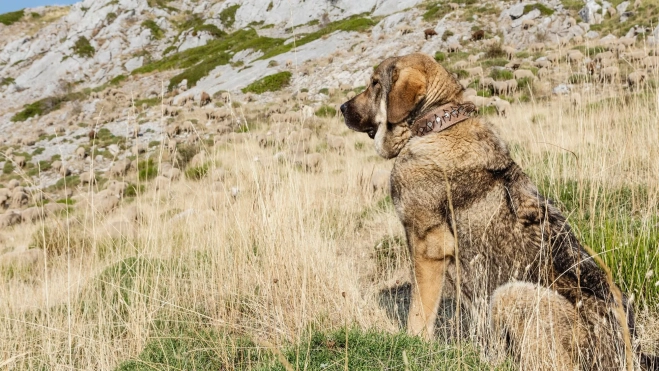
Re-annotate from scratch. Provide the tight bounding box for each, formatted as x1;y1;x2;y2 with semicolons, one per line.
0;0;659;218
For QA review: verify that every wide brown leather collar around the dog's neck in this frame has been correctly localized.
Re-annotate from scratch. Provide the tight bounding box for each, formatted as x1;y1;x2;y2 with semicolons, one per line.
410;102;476;137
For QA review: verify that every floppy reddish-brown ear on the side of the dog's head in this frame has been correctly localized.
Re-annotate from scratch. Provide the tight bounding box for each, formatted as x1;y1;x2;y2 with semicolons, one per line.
387;67;427;124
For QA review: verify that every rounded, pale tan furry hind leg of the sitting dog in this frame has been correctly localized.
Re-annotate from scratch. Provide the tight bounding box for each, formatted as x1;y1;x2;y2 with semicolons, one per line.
489;282;586;371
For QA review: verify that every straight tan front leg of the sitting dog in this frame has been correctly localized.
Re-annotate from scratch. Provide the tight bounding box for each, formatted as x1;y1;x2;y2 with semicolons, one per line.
407;226;455;339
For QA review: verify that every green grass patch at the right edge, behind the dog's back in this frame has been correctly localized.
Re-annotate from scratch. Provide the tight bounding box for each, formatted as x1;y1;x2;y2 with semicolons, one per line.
537;177;659;306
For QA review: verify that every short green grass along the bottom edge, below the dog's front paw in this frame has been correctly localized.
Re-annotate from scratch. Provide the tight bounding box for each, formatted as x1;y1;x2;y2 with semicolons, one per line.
116;319;513;371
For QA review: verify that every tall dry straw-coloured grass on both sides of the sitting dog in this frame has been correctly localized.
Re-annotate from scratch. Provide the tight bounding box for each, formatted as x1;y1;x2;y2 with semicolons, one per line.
0;80;659;370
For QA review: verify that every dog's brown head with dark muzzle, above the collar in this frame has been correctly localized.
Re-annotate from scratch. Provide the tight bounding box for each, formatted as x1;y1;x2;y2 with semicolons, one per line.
341;54;463;158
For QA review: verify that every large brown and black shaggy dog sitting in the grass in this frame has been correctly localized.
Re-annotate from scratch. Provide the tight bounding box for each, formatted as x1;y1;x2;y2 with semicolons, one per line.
340;54;658;370
